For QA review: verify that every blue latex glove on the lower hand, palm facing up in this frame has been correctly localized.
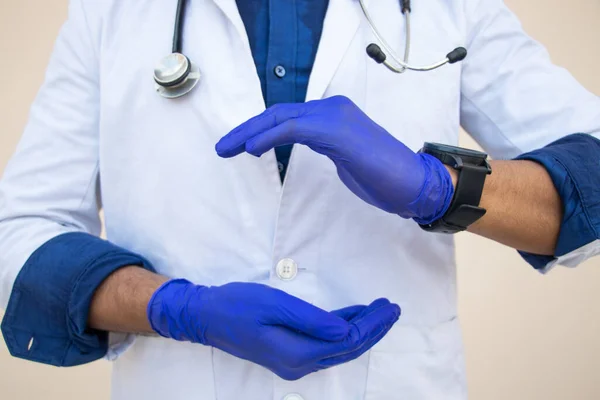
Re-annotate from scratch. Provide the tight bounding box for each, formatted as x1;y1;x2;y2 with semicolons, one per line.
147;279;400;380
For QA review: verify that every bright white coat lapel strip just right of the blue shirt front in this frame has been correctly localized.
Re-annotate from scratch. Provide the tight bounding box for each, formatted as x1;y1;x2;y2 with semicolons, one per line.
306;0;368;101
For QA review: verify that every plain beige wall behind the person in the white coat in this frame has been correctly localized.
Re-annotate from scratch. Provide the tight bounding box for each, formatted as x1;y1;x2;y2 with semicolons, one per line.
0;0;600;400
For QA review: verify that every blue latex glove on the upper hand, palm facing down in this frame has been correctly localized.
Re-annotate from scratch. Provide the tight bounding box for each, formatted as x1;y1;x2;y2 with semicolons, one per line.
216;96;454;224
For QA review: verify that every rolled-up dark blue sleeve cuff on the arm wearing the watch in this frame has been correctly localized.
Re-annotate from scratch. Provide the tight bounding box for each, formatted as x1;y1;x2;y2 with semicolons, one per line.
516;134;600;270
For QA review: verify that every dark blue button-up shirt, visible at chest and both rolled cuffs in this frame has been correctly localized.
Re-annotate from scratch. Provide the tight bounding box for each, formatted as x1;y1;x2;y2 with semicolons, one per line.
2;0;600;366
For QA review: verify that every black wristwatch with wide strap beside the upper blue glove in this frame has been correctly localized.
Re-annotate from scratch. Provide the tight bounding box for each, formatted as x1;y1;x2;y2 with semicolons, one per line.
419;143;492;233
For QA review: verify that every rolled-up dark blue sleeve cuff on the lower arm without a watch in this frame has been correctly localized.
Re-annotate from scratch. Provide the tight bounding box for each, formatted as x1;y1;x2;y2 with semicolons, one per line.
2;232;154;366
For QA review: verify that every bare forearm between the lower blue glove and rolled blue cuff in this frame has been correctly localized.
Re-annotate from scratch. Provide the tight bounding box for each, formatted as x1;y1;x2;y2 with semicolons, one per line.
88;266;168;333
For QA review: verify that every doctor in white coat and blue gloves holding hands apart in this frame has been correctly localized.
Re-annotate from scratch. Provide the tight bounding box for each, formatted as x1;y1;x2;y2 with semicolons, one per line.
0;0;600;400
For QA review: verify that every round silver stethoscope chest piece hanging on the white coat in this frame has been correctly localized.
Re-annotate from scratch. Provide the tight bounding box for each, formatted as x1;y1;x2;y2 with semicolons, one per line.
154;53;201;99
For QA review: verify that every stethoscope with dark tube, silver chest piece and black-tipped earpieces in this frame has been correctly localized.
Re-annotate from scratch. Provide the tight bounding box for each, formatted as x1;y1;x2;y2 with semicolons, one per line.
154;0;467;99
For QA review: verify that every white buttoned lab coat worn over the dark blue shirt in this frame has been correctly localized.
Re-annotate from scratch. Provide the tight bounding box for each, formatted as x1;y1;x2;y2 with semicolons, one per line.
0;0;600;400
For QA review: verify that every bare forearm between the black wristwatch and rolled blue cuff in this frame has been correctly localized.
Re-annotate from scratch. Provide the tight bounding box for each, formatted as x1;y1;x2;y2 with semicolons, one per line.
452;161;563;255
